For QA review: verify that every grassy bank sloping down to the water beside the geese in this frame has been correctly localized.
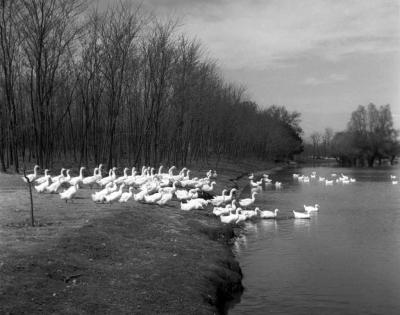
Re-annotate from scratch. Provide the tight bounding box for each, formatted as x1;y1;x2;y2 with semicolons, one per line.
0;162;282;314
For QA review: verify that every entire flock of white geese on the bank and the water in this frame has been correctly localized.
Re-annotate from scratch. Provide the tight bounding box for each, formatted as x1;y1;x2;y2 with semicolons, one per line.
22;164;397;224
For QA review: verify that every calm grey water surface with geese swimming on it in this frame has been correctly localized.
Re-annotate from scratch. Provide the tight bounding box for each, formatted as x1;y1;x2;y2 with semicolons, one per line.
229;167;400;315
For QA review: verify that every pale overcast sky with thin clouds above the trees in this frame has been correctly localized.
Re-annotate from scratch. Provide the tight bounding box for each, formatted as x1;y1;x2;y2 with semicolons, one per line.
102;0;400;135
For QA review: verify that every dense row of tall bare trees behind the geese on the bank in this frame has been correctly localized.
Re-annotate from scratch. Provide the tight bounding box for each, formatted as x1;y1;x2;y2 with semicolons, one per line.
0;0;302;172
